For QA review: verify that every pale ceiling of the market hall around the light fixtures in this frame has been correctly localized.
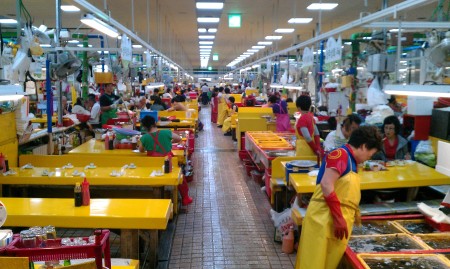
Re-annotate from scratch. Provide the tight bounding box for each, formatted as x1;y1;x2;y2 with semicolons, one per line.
0;0;437;70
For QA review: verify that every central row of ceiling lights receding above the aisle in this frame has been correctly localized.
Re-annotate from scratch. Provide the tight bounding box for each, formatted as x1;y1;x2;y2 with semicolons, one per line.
195;0;224;68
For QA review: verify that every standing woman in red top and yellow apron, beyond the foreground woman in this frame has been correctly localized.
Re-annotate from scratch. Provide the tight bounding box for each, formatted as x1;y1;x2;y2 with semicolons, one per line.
295;95;323;157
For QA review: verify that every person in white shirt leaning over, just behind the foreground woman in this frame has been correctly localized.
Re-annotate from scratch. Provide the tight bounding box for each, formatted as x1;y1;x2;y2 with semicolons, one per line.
323;114;361;152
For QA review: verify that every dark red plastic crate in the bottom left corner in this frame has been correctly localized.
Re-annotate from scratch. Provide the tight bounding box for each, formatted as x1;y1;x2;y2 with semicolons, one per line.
4;230;111;268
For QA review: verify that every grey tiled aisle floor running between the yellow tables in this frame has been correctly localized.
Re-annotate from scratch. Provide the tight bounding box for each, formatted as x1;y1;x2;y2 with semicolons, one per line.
169;107;295;269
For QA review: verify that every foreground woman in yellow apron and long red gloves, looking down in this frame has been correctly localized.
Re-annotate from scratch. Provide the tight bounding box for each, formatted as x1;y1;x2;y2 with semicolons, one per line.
295;126;381;269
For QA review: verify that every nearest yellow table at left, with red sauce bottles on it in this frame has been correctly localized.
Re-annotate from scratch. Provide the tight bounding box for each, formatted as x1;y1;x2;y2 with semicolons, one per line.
1;197;172;264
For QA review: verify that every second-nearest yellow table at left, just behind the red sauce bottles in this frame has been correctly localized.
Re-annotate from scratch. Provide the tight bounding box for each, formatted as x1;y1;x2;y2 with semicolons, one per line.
0;163;182;213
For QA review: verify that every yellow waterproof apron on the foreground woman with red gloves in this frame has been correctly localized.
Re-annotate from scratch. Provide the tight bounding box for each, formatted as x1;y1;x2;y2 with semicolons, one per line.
295;149;361;269
